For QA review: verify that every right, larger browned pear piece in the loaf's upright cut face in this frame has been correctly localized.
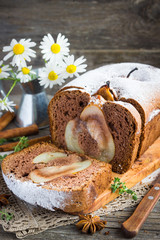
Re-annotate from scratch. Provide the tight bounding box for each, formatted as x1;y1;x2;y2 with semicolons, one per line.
80;104;115;162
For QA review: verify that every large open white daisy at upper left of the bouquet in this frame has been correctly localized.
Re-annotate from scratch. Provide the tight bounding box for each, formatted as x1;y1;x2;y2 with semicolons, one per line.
3;39;36;67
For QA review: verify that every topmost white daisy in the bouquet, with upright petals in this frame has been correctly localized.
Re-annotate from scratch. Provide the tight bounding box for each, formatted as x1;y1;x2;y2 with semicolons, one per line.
39;33;70;62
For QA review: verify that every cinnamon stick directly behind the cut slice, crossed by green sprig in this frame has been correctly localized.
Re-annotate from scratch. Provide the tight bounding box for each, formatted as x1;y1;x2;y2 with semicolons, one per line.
0;135;51;152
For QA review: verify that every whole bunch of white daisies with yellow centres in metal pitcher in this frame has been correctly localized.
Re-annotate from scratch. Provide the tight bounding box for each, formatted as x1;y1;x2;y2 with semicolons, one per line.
0;33;87;111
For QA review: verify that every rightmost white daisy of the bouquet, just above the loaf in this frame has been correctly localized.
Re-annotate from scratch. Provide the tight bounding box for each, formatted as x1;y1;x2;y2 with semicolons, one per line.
62;55;87;78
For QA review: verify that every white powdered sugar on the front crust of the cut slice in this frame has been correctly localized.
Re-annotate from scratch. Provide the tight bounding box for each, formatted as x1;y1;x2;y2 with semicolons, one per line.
3;173;72;211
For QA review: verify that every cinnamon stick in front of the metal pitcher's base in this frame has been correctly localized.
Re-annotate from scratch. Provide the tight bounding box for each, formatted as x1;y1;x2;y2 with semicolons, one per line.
0;124;38;139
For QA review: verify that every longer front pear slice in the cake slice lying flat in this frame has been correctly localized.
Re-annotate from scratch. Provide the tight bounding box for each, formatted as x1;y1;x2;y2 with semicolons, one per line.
29;160;91;183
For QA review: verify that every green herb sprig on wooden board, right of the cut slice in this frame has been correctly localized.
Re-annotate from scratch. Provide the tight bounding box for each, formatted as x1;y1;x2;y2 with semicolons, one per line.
111;177;137;201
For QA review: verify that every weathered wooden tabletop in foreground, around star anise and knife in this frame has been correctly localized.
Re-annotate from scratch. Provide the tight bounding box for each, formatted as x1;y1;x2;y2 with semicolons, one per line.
0;204;160;240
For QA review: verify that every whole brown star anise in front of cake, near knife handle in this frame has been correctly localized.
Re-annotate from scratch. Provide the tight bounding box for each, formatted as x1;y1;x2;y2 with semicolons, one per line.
76;215;107;234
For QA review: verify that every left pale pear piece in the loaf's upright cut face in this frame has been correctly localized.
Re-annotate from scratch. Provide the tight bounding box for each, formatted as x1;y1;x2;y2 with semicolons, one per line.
65;120;84;154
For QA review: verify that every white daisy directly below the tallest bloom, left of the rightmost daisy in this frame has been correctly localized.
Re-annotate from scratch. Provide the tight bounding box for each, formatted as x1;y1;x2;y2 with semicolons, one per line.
39;62;64;88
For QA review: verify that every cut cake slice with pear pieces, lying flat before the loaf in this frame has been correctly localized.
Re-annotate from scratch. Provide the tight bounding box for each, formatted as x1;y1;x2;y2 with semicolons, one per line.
2;142;112;213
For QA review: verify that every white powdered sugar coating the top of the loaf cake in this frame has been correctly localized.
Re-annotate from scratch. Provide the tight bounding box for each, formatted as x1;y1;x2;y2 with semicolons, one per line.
66;63;160;122
